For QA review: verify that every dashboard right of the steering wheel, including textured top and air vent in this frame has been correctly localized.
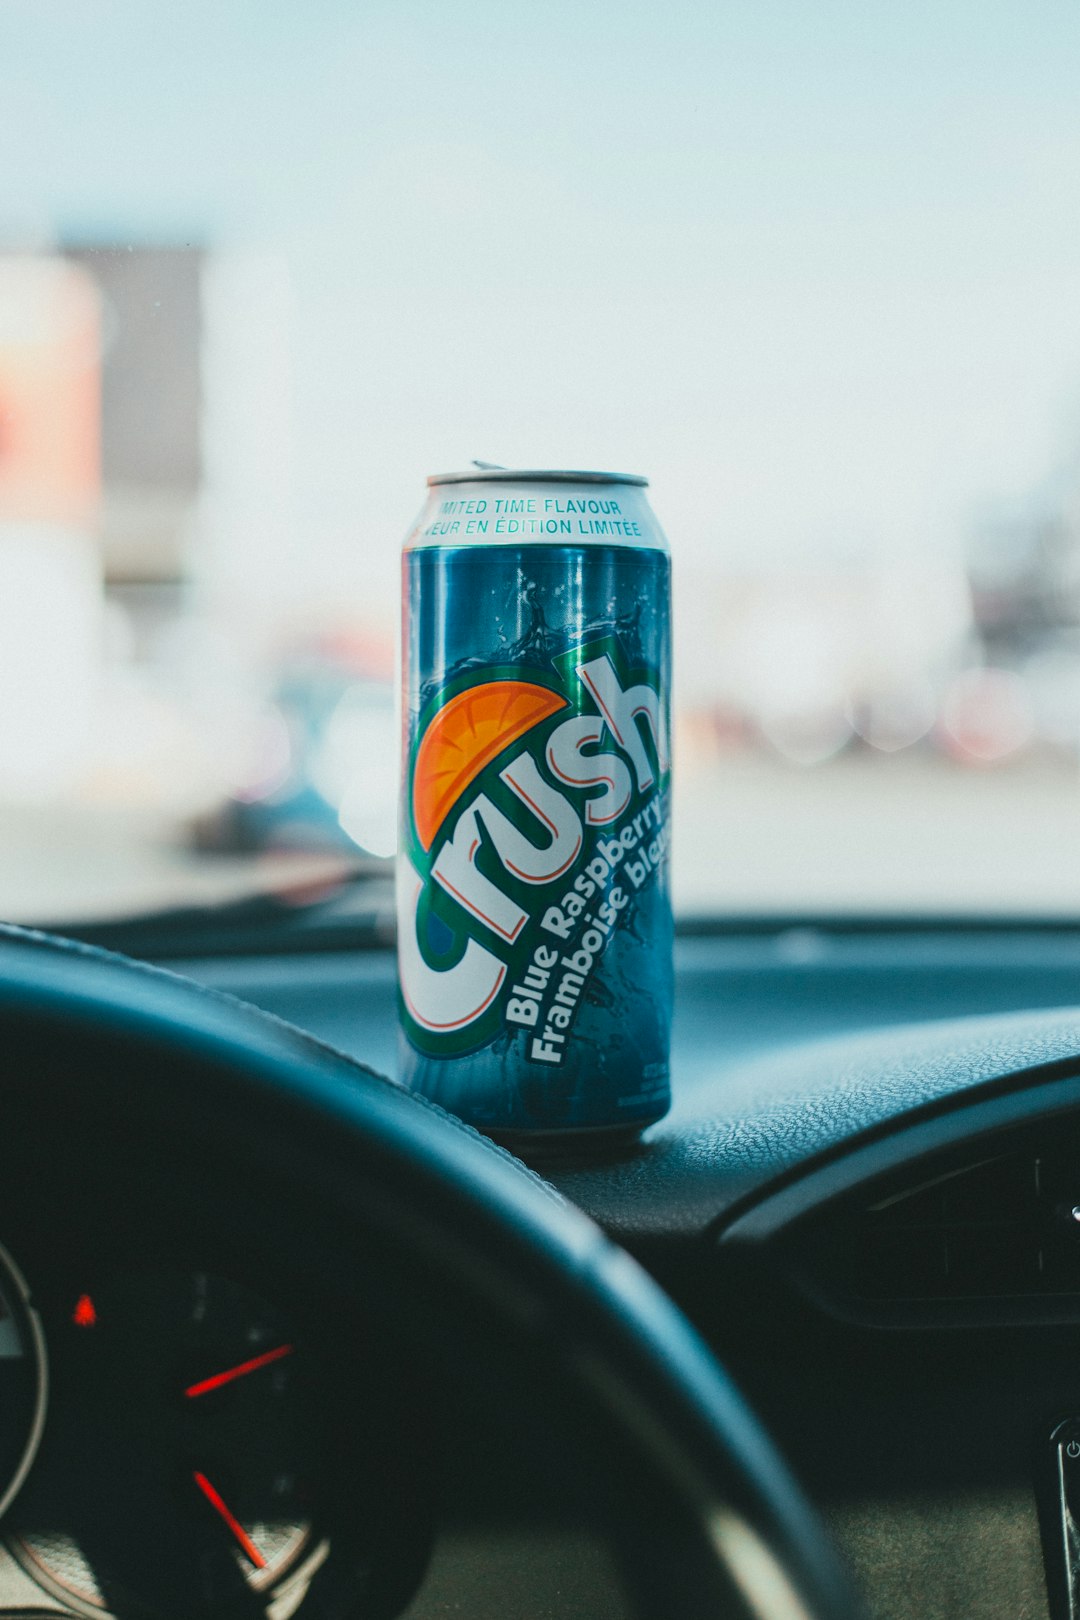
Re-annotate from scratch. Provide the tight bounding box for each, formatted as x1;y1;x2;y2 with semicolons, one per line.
183;923;1080;1620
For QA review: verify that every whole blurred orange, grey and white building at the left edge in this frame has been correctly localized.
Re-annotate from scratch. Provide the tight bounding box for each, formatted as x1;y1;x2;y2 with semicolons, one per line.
0;246;215;802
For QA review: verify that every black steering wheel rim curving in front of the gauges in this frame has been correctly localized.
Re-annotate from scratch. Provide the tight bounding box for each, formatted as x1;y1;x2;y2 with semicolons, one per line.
0;927;857;1620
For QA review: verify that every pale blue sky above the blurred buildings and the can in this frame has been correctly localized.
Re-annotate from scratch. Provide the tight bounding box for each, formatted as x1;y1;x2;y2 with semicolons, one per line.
0;0;1080;602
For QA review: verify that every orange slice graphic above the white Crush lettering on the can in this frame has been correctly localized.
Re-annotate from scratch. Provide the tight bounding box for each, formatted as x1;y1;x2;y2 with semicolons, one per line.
413;680;567;849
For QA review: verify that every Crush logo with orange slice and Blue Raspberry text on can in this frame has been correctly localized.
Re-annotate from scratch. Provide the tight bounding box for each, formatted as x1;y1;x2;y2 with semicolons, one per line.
398;637;669;1064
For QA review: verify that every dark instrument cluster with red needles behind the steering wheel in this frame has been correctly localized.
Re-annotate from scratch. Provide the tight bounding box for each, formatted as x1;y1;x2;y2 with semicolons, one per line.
0;1249;424;1620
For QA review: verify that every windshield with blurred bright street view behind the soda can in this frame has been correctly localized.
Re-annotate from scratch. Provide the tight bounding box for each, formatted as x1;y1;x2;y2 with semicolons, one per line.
0;0;1080;922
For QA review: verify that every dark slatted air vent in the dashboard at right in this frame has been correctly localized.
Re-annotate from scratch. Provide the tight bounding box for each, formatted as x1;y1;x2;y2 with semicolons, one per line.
829;1150;1080;1299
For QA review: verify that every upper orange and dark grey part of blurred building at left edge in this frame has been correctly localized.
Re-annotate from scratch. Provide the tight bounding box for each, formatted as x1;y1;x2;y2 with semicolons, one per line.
0;246;204;644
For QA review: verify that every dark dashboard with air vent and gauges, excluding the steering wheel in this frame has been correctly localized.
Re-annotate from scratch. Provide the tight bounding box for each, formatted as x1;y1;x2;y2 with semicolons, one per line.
0;925;1080;1620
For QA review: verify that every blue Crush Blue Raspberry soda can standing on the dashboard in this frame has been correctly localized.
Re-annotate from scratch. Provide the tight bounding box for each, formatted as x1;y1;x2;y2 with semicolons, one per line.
397;467;672;1155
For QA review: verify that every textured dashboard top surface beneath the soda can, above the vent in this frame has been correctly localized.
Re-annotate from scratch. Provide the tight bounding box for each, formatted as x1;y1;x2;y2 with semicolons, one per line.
172;928;1080;1246
